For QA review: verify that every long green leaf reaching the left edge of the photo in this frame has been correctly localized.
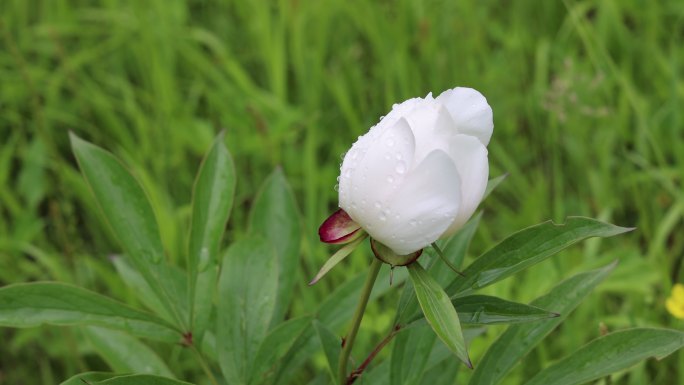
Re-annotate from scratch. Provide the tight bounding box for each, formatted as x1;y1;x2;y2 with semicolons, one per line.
0;282;181;342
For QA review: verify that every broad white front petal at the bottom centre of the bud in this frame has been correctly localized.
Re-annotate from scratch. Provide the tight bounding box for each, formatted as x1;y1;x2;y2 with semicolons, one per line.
367;150;461;255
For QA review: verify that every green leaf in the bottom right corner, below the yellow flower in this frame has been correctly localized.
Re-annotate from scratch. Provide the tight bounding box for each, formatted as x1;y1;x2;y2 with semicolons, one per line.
527;328;684;385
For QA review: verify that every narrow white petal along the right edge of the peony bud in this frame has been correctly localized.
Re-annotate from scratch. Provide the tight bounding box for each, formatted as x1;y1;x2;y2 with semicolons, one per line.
444;135;489;236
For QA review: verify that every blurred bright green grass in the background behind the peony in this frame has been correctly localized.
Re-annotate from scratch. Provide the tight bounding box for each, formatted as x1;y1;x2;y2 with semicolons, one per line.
0;0;684;384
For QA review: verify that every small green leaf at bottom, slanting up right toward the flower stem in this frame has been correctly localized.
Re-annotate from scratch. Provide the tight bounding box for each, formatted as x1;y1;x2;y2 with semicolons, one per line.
250;316;313;384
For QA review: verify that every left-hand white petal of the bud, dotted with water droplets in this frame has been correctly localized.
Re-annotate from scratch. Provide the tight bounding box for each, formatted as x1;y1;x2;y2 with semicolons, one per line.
340;118;415;231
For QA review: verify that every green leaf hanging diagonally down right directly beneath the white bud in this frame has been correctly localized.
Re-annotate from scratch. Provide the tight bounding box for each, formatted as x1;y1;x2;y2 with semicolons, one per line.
408;263;472;368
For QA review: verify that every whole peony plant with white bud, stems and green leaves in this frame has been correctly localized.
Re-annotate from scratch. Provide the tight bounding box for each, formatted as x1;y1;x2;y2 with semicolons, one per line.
0;92;684;385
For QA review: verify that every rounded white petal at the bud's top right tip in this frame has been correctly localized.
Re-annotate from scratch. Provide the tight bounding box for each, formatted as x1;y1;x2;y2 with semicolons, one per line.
436;87;494;146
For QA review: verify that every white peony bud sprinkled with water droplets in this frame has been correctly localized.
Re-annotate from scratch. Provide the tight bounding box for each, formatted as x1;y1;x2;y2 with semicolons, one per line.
332;87;494;255
